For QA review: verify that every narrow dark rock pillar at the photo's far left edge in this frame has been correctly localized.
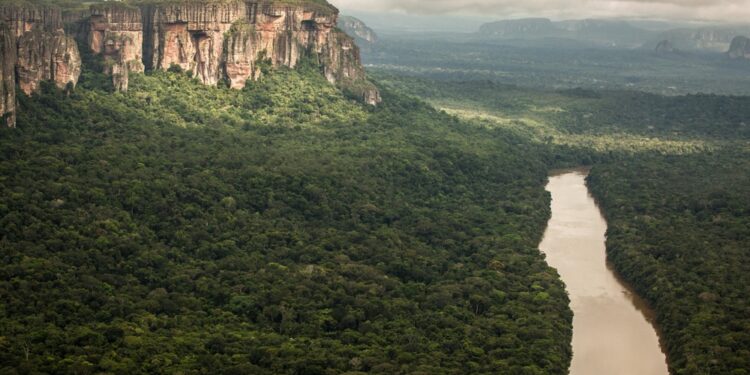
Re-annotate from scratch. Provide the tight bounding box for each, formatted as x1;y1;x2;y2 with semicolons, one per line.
0;23;16;127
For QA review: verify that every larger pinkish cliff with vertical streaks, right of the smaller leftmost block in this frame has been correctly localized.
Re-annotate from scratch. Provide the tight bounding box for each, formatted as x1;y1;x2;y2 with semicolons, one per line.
79;0;380;104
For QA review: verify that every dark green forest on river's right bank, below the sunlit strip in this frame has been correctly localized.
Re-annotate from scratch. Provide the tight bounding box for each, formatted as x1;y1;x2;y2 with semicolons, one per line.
588;150;750;375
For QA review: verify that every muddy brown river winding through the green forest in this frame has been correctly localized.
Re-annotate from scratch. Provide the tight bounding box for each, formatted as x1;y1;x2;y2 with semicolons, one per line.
539;170;669;375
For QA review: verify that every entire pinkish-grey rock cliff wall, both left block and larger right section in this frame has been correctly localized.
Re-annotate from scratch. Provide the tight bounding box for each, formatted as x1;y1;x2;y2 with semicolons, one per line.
0;0;381;126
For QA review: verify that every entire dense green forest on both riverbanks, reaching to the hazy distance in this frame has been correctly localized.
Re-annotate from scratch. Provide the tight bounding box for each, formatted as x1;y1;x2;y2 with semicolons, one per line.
0;8;750;375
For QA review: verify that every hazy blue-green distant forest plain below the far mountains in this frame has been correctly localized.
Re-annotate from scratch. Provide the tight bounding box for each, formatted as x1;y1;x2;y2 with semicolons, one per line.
363;33;750;96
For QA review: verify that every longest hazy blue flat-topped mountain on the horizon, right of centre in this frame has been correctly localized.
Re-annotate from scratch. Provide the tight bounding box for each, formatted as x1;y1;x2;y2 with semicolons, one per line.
479;18;654;48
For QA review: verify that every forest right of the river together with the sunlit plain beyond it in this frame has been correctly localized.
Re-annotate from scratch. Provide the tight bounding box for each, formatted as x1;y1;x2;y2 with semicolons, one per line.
376;70;750;375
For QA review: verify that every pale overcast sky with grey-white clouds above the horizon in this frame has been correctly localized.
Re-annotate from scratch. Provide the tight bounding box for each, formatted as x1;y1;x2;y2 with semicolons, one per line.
329;0;750;23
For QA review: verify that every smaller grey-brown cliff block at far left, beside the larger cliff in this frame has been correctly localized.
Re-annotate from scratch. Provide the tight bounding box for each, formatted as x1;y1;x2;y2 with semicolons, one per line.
0;6;81;126
